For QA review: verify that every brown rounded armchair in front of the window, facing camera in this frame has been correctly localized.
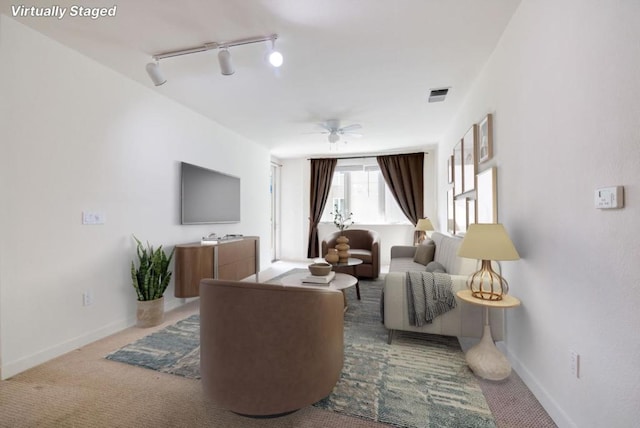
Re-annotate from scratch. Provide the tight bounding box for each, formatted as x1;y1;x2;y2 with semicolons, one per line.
321;229;380;279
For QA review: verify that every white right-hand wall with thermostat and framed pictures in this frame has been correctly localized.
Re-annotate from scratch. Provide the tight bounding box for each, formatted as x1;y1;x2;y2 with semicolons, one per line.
439;0;640;427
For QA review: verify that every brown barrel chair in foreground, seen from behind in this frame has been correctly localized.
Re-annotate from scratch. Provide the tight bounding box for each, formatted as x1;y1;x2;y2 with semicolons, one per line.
200;279;344;416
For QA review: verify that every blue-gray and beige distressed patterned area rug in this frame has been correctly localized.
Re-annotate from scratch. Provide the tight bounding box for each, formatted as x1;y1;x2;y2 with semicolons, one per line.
106;272;496;428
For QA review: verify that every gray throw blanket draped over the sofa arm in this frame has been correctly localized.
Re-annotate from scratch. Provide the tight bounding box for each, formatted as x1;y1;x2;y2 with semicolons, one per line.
406;271;456;327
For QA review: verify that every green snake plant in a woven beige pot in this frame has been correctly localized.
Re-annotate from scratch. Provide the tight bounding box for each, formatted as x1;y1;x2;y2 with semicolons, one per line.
131;236;175;327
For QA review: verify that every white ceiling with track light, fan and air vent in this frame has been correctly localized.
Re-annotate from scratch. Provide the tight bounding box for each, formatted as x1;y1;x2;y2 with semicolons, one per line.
2;0;520;158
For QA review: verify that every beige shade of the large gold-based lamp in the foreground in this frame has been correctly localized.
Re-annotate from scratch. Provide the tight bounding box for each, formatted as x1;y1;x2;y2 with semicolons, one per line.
458;223;520;260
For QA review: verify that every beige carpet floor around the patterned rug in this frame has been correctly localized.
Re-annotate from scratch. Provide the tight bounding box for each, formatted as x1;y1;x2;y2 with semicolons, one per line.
0;296;555;428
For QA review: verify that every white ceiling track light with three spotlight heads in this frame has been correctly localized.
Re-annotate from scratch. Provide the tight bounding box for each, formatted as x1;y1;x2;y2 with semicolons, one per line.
147;34;283;86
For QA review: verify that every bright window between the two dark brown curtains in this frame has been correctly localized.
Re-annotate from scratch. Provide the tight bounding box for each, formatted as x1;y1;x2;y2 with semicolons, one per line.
322;158;409;224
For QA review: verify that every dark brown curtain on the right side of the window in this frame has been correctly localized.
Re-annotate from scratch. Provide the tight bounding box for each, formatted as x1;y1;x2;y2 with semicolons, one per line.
376;153;424;226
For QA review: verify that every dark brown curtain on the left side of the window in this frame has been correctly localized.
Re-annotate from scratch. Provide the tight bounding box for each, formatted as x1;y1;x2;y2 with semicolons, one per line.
307;159;338;258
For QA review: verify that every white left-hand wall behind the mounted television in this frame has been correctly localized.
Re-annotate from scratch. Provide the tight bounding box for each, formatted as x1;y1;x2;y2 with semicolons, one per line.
0;16;270;378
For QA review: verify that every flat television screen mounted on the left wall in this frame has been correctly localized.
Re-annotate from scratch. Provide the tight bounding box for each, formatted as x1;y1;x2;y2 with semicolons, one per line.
181;162;240;224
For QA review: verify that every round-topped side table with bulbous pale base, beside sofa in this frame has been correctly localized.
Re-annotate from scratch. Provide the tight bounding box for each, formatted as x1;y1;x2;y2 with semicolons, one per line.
456;290;520;380
